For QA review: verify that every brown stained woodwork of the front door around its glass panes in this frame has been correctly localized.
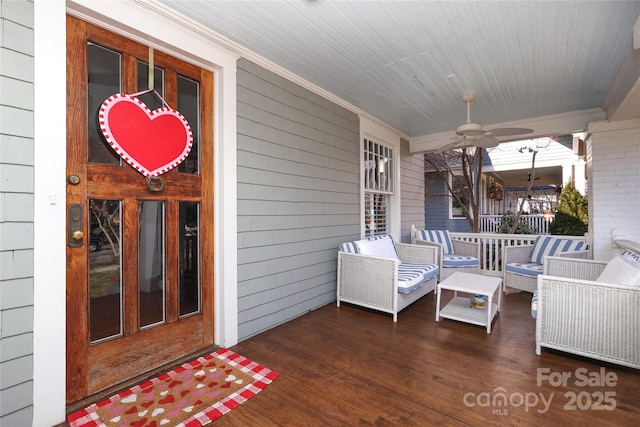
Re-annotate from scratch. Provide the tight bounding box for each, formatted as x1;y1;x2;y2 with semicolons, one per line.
66;16;215;404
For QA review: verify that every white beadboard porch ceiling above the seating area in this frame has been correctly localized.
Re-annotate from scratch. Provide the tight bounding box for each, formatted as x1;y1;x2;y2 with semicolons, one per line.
161;0;640;145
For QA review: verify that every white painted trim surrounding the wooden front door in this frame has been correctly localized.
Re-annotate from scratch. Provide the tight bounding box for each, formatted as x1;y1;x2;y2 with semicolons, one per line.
31;0;239;425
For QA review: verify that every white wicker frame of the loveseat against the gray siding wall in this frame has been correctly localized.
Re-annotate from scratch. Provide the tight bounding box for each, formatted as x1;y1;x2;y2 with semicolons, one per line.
337;239;437;322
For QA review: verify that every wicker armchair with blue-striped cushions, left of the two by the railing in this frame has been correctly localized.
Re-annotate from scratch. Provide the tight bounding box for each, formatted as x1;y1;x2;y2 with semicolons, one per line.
411;225;480;282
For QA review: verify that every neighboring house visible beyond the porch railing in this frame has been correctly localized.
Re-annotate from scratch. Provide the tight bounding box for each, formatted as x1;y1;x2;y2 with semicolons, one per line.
425;133;587;232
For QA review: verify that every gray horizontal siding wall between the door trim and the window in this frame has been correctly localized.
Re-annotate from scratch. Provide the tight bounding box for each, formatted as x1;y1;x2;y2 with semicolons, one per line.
237;60;360;340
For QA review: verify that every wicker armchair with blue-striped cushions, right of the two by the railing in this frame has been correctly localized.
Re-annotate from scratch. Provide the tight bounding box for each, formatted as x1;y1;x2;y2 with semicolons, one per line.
502;236;589;292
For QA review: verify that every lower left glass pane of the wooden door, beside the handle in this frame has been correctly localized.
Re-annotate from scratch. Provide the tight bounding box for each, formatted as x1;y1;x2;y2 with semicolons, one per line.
87;199;122;343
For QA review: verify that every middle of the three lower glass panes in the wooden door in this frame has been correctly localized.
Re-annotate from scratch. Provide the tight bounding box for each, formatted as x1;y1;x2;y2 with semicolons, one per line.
138;201;165;328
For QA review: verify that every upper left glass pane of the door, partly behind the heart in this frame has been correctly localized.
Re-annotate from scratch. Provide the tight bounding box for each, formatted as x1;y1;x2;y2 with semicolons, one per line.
87;42;122;166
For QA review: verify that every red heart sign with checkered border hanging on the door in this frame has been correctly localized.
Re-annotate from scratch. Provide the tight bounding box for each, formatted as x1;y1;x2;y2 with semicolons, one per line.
99;93;193;178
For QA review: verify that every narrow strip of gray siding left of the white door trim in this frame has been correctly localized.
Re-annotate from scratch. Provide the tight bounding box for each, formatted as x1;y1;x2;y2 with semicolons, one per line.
0;0;34;426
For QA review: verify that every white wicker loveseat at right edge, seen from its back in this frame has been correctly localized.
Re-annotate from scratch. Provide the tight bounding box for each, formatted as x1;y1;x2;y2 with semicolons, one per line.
535;255;640;369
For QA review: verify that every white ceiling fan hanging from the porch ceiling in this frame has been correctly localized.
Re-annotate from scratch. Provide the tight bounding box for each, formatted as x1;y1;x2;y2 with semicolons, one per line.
438;92;533;152
